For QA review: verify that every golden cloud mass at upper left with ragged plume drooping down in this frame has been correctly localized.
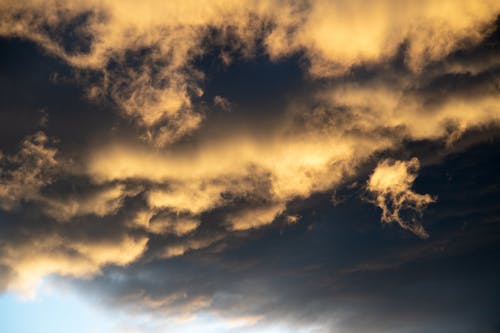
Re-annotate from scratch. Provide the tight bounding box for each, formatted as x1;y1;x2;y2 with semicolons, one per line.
0;0;269;145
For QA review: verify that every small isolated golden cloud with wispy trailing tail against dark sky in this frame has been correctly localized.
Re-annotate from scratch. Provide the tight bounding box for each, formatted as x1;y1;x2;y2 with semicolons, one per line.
367;158;436;238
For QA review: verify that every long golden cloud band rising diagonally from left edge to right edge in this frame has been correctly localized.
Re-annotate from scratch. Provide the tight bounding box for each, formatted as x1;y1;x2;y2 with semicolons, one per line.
2;35;499;296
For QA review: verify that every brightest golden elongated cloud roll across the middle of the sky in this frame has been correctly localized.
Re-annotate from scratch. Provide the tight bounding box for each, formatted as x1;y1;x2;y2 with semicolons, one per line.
87;133;368;196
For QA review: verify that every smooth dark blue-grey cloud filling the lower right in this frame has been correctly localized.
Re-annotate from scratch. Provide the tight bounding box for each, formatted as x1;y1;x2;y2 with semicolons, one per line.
42;141;498;332
